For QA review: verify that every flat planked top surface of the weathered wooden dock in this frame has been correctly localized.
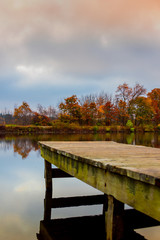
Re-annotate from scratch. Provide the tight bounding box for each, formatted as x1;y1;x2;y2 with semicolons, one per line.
40;141;160;185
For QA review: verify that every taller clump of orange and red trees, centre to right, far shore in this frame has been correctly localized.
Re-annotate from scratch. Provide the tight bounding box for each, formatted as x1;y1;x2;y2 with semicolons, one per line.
59;83;160;126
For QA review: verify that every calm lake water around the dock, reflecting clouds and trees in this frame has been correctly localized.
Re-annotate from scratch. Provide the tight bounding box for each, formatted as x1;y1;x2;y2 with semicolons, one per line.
0;133;160;240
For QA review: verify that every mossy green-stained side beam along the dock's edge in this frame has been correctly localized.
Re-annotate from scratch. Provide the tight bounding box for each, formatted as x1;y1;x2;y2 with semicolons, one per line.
41;144;160;221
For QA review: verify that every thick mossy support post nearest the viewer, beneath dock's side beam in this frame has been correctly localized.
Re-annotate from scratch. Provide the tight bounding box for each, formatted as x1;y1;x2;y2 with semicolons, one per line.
105;195;124;240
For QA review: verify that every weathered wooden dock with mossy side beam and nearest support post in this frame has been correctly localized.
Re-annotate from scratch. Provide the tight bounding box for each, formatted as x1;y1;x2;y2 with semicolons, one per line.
40;141;160;240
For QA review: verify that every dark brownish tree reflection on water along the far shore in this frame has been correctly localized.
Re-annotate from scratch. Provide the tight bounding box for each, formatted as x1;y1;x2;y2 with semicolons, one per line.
0;133;160;159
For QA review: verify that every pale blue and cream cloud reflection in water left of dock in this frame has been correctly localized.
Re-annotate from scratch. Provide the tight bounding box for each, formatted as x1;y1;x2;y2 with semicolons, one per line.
0;148;44;240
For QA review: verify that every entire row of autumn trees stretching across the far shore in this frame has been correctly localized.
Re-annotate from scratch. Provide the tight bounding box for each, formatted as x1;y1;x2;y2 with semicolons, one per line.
0;83;160;126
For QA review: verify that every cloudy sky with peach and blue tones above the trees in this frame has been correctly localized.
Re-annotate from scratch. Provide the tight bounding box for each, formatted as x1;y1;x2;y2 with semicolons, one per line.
0;0;160;111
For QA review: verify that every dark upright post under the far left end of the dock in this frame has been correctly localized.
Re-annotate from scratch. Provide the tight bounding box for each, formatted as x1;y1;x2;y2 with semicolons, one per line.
44;160;52;220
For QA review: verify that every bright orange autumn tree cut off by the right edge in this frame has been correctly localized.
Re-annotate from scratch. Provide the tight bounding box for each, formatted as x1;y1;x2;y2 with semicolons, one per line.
147;88;160;125
